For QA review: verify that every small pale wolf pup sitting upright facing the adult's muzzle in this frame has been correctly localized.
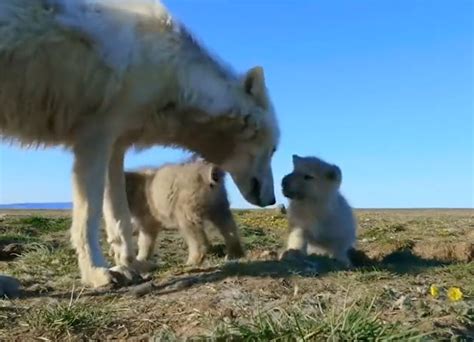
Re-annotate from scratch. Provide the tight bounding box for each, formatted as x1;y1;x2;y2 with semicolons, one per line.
282;155;356;266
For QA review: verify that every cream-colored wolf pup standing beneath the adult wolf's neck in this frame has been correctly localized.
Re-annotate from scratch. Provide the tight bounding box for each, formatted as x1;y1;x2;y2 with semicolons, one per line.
125;159;244;270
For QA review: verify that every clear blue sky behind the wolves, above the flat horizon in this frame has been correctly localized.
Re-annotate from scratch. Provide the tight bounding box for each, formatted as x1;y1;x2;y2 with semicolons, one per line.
0;0;474;208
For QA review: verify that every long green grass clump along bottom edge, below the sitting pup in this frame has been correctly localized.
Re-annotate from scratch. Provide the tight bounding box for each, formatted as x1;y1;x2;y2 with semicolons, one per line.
212;303;429;341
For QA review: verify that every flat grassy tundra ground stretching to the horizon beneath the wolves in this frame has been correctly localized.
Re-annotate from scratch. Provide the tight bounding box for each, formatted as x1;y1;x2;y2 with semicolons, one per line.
0;210;474;341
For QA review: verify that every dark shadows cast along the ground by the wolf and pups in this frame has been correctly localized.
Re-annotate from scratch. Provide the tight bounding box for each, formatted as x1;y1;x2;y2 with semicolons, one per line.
22;249;470;298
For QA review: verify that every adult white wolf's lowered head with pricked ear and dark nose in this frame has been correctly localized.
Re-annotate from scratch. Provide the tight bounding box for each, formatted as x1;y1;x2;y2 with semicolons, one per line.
216;67;280;207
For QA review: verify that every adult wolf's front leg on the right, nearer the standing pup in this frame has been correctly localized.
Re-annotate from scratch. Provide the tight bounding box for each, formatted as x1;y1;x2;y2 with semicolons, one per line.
103;144;142;280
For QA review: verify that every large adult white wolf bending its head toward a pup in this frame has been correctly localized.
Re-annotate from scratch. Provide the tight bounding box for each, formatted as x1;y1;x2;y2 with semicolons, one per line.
0;0;279;287
